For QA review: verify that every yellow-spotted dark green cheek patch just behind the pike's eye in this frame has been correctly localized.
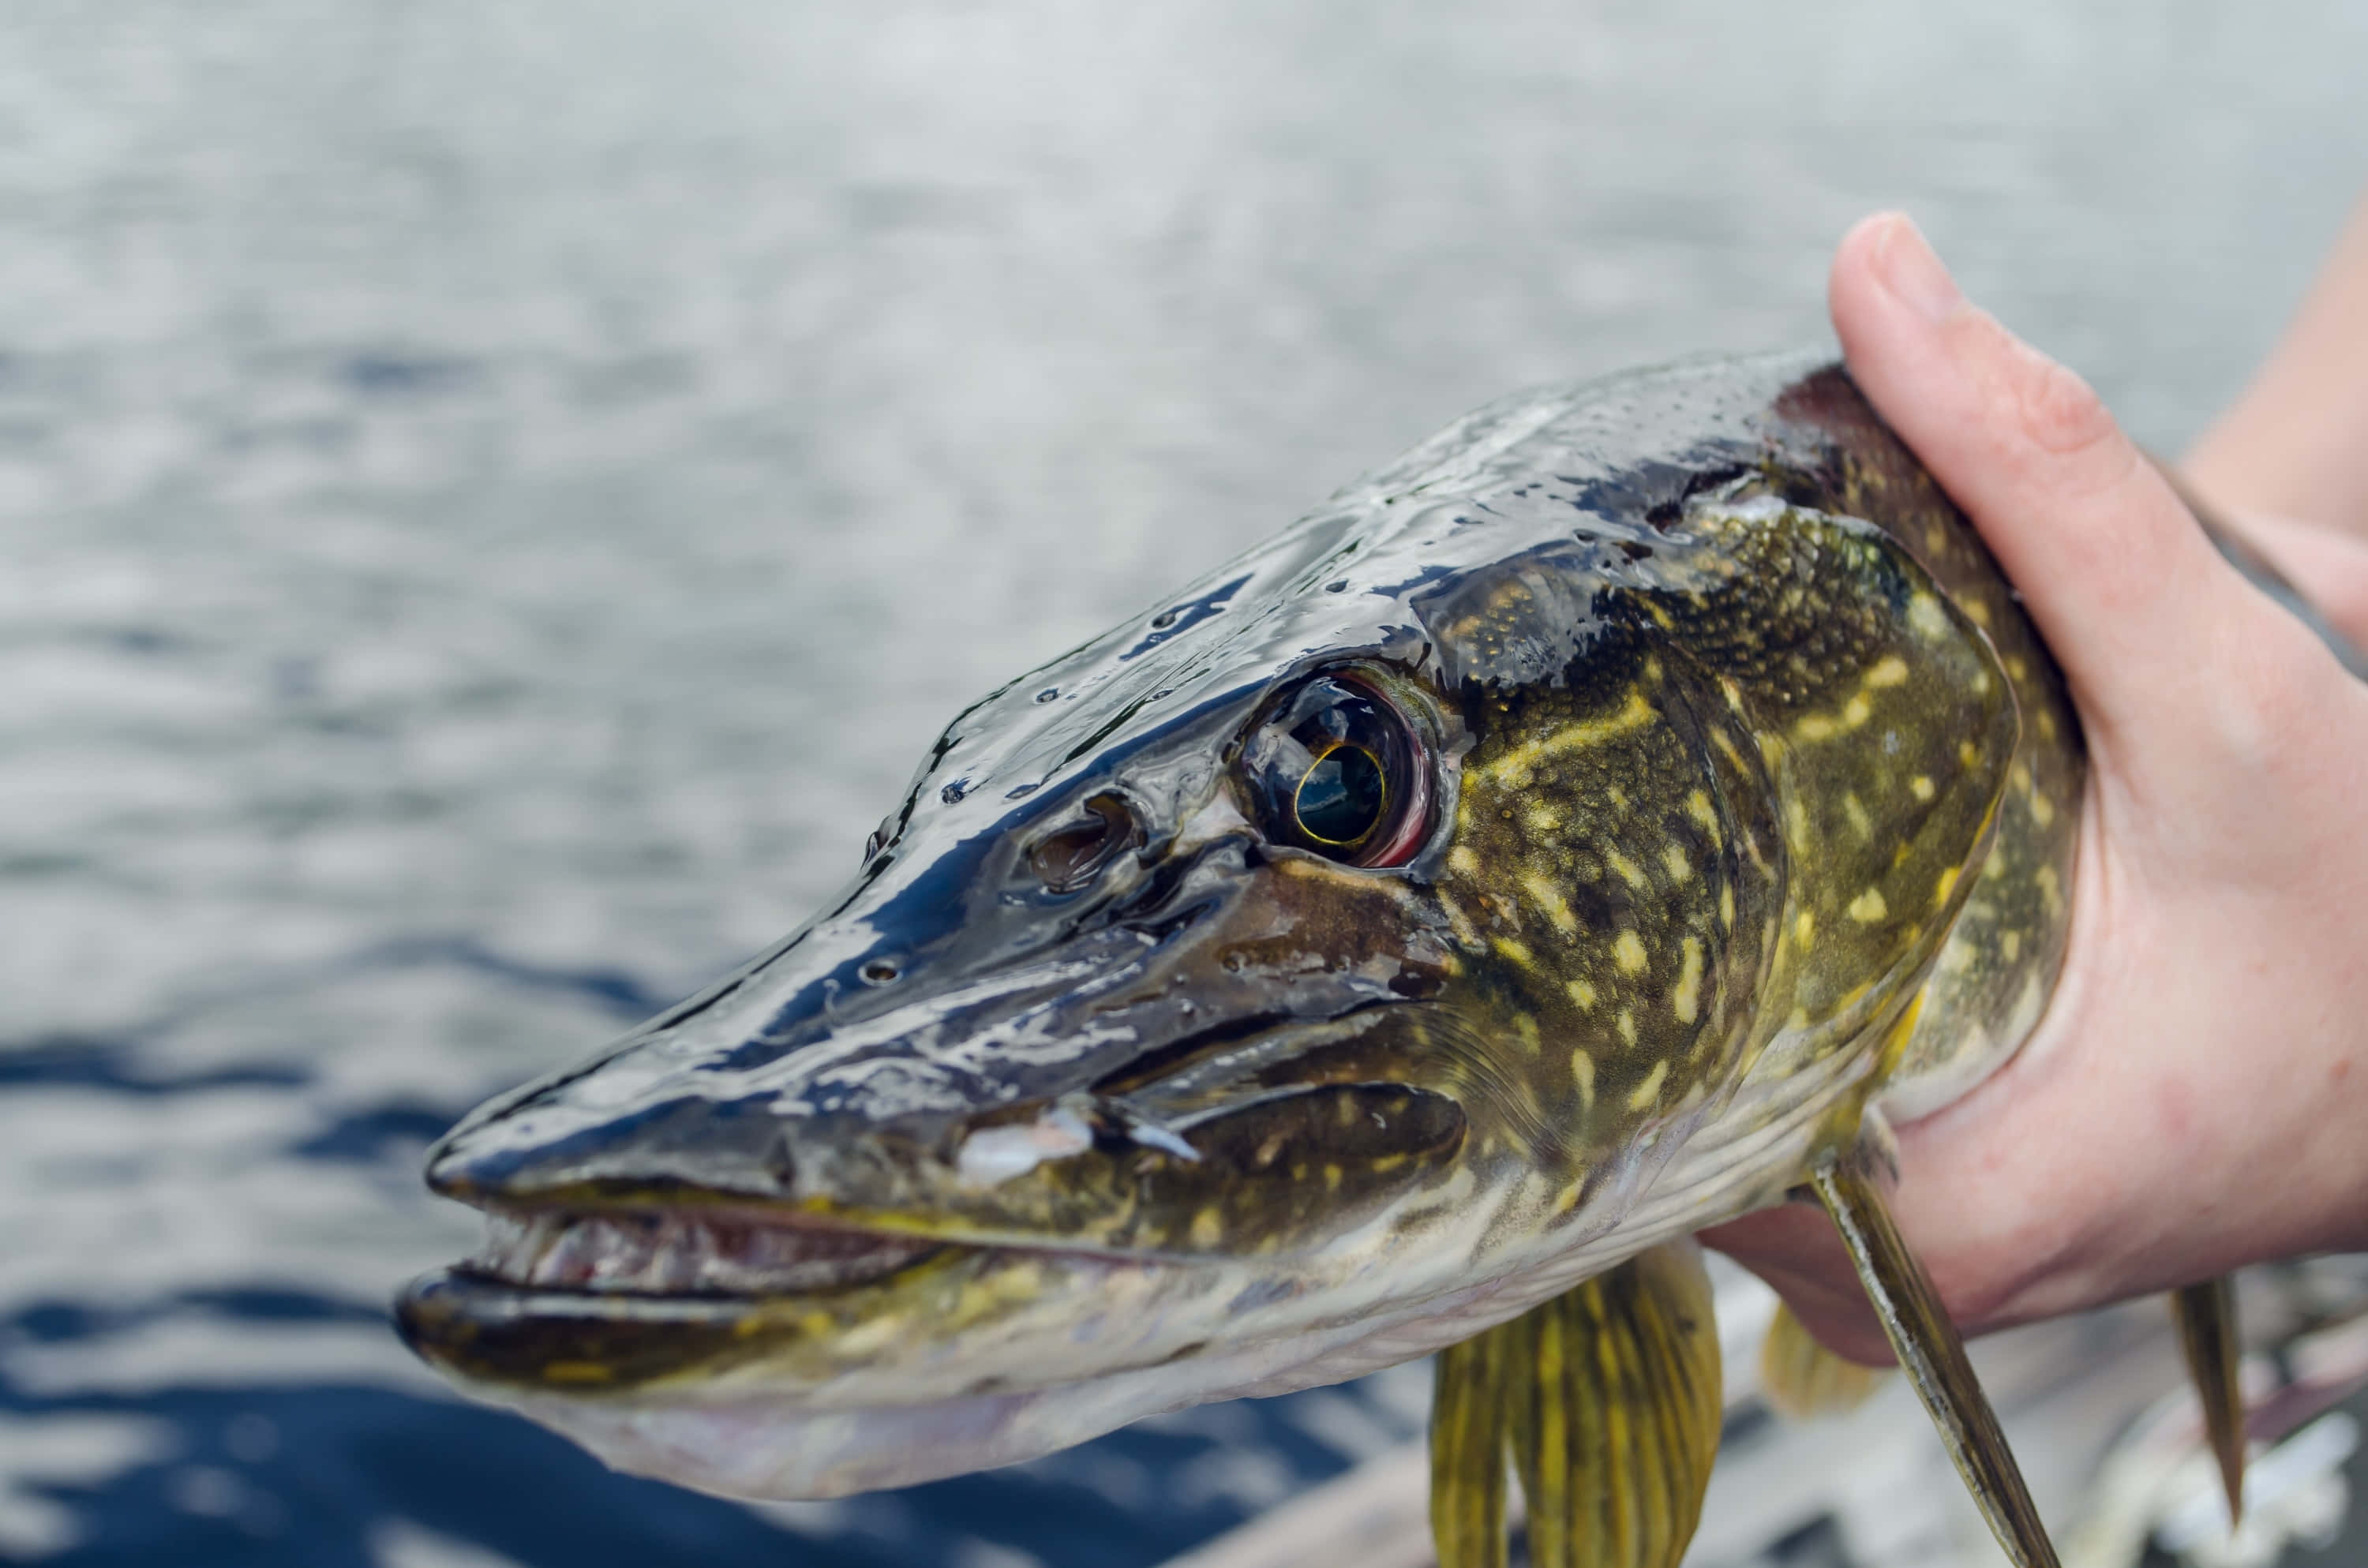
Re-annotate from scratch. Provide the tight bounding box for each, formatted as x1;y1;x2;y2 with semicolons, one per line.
1411;639;1776;1170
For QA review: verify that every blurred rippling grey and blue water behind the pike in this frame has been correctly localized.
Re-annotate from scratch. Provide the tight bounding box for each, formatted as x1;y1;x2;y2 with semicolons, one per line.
0;0;2368;1568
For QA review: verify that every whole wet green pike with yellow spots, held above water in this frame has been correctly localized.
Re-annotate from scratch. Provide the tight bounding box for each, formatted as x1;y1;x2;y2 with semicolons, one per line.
398;355;2264;1568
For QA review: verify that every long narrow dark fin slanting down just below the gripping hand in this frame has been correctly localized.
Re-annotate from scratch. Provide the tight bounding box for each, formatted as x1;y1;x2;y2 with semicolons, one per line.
1809;1151;2055;1568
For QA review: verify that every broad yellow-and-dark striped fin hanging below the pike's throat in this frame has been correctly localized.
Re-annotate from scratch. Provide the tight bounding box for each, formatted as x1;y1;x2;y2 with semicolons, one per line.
1430;1241;1719;1568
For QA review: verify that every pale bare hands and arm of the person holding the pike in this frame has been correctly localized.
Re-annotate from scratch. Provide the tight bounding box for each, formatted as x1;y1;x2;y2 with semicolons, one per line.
1705;206;2368;1362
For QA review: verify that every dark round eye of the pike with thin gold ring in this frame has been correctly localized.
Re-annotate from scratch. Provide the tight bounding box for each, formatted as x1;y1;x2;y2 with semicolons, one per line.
1238;672;1430;867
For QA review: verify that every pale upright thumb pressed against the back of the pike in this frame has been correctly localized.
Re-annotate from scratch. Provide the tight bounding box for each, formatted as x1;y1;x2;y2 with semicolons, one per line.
1828;213;2231;727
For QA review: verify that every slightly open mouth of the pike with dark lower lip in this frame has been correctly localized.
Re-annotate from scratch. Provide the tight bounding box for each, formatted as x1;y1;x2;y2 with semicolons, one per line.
395;1206;1179;1393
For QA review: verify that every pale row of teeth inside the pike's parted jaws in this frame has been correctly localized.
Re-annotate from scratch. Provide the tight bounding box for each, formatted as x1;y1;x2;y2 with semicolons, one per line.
471;1213;933;1296
